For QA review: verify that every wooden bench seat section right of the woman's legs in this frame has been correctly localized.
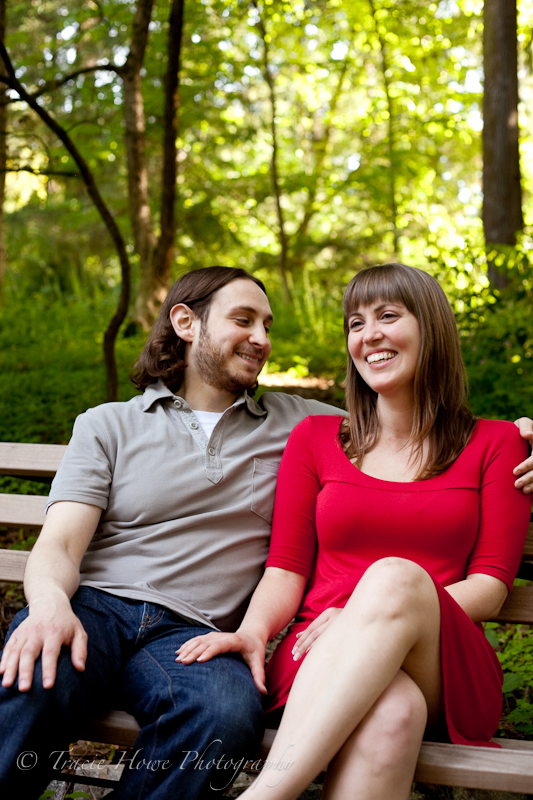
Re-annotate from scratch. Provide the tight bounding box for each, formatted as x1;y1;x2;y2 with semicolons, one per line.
415;742;533;793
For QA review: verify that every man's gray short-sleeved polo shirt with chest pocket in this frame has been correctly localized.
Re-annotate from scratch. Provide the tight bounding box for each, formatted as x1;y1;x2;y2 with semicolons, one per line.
49;382;342;630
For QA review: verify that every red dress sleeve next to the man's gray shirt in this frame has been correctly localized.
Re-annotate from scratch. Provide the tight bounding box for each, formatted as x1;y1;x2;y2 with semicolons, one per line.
266;417;321;578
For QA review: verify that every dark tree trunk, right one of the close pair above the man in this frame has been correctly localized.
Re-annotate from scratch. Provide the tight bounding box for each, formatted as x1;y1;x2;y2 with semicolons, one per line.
133;0;185;329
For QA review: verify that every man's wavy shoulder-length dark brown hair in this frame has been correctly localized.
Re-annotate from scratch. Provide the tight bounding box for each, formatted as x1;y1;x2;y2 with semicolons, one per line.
130;266;266;392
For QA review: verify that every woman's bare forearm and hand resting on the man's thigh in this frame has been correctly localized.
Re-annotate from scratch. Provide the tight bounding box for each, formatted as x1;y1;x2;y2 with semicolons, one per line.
176;567;307;694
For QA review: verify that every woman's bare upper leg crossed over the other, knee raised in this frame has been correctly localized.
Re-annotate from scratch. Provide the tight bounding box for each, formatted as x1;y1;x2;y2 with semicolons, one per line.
241;558;442;800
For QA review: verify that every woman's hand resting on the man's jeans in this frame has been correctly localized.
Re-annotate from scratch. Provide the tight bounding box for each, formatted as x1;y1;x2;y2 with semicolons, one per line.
176;631;267;694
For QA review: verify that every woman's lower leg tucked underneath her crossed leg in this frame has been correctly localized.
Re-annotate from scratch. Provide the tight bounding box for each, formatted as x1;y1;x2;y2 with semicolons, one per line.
322;670;427;800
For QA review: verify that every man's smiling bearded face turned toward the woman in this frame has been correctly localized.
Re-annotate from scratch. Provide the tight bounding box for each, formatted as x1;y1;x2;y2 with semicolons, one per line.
188;278;272;396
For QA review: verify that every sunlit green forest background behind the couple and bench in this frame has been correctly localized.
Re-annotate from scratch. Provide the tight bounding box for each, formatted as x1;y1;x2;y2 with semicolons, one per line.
0;0;533;735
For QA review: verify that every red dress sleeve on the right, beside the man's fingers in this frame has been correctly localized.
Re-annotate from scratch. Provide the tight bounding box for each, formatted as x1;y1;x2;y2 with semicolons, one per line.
467;422;531;591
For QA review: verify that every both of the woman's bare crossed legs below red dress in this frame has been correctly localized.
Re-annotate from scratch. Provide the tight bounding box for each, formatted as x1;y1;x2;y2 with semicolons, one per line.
248;557;443;800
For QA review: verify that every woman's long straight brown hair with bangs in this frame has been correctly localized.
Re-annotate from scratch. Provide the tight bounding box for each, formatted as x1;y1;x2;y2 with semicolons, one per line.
339;264;476;480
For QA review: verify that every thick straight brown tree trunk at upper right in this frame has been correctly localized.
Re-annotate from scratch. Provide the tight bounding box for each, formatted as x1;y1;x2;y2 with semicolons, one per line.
483;0;524;289
